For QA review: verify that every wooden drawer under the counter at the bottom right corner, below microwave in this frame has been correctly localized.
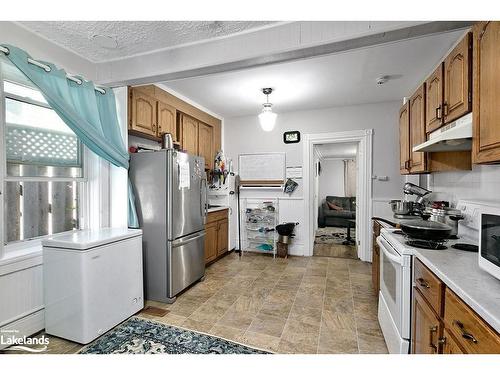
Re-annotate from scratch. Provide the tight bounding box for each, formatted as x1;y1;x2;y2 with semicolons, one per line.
444;288;500;354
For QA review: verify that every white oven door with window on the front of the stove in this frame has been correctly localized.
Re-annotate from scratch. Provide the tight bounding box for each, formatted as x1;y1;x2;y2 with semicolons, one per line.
377;236;411;340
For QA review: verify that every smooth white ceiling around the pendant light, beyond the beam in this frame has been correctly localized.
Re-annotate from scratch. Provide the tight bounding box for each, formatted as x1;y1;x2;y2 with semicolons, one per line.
162;31;464;117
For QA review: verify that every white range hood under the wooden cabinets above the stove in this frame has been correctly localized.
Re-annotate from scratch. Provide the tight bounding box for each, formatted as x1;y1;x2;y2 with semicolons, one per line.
413;113;472;152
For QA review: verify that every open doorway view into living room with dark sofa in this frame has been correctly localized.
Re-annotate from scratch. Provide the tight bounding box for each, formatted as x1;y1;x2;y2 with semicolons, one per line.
313;142;358;259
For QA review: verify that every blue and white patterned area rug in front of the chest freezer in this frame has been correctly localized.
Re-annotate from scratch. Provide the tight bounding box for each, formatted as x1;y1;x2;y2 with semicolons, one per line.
79;317;269;354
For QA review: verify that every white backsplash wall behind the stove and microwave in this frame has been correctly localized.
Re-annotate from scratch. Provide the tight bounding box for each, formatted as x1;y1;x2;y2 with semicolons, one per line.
421;165;500;205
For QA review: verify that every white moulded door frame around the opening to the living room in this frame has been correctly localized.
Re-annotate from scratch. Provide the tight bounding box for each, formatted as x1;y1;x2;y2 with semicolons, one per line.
303;129;373;261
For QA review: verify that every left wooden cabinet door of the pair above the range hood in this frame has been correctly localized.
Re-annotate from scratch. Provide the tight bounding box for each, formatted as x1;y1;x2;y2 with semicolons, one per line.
425;64;443;133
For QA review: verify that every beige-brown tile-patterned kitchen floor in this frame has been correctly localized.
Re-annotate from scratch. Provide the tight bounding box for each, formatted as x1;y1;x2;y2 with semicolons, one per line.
10;253;387;353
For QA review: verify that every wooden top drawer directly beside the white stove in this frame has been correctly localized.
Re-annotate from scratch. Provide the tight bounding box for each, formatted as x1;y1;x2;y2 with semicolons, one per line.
414;259;444;316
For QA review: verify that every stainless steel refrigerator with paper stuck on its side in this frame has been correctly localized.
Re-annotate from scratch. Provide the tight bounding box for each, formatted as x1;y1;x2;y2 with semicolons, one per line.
129;150;207;303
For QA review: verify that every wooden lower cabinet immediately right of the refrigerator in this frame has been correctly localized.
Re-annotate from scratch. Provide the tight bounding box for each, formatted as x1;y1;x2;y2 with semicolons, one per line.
205;210;229;263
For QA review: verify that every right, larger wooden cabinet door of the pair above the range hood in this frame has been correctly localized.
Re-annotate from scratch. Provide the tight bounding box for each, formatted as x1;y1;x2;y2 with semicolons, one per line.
443;33;472;123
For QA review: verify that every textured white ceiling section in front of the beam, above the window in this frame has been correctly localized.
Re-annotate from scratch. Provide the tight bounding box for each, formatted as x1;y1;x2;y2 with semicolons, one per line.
19;21;273;62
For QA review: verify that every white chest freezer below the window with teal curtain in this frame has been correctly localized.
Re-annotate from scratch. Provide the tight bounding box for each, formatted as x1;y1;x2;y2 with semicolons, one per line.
42;228;144;344
